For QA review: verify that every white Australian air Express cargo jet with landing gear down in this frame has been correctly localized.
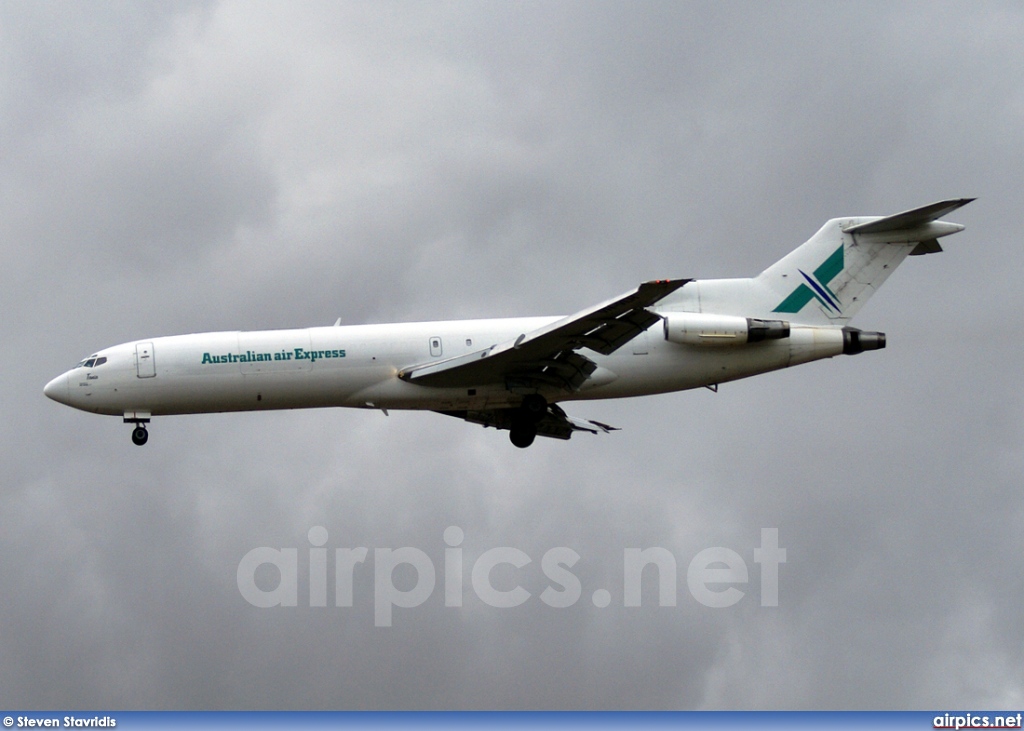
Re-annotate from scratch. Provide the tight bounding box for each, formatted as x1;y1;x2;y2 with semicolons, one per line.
43;198;974;447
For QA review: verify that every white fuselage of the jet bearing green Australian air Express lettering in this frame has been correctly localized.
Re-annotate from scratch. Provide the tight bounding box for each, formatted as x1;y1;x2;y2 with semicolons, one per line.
45;317;843;417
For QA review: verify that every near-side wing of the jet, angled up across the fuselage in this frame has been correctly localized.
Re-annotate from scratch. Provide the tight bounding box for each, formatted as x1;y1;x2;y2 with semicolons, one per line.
398;280;692;391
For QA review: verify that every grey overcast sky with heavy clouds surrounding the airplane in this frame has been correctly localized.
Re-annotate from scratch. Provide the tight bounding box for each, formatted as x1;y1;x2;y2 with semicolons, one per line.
0;0;1024;710
